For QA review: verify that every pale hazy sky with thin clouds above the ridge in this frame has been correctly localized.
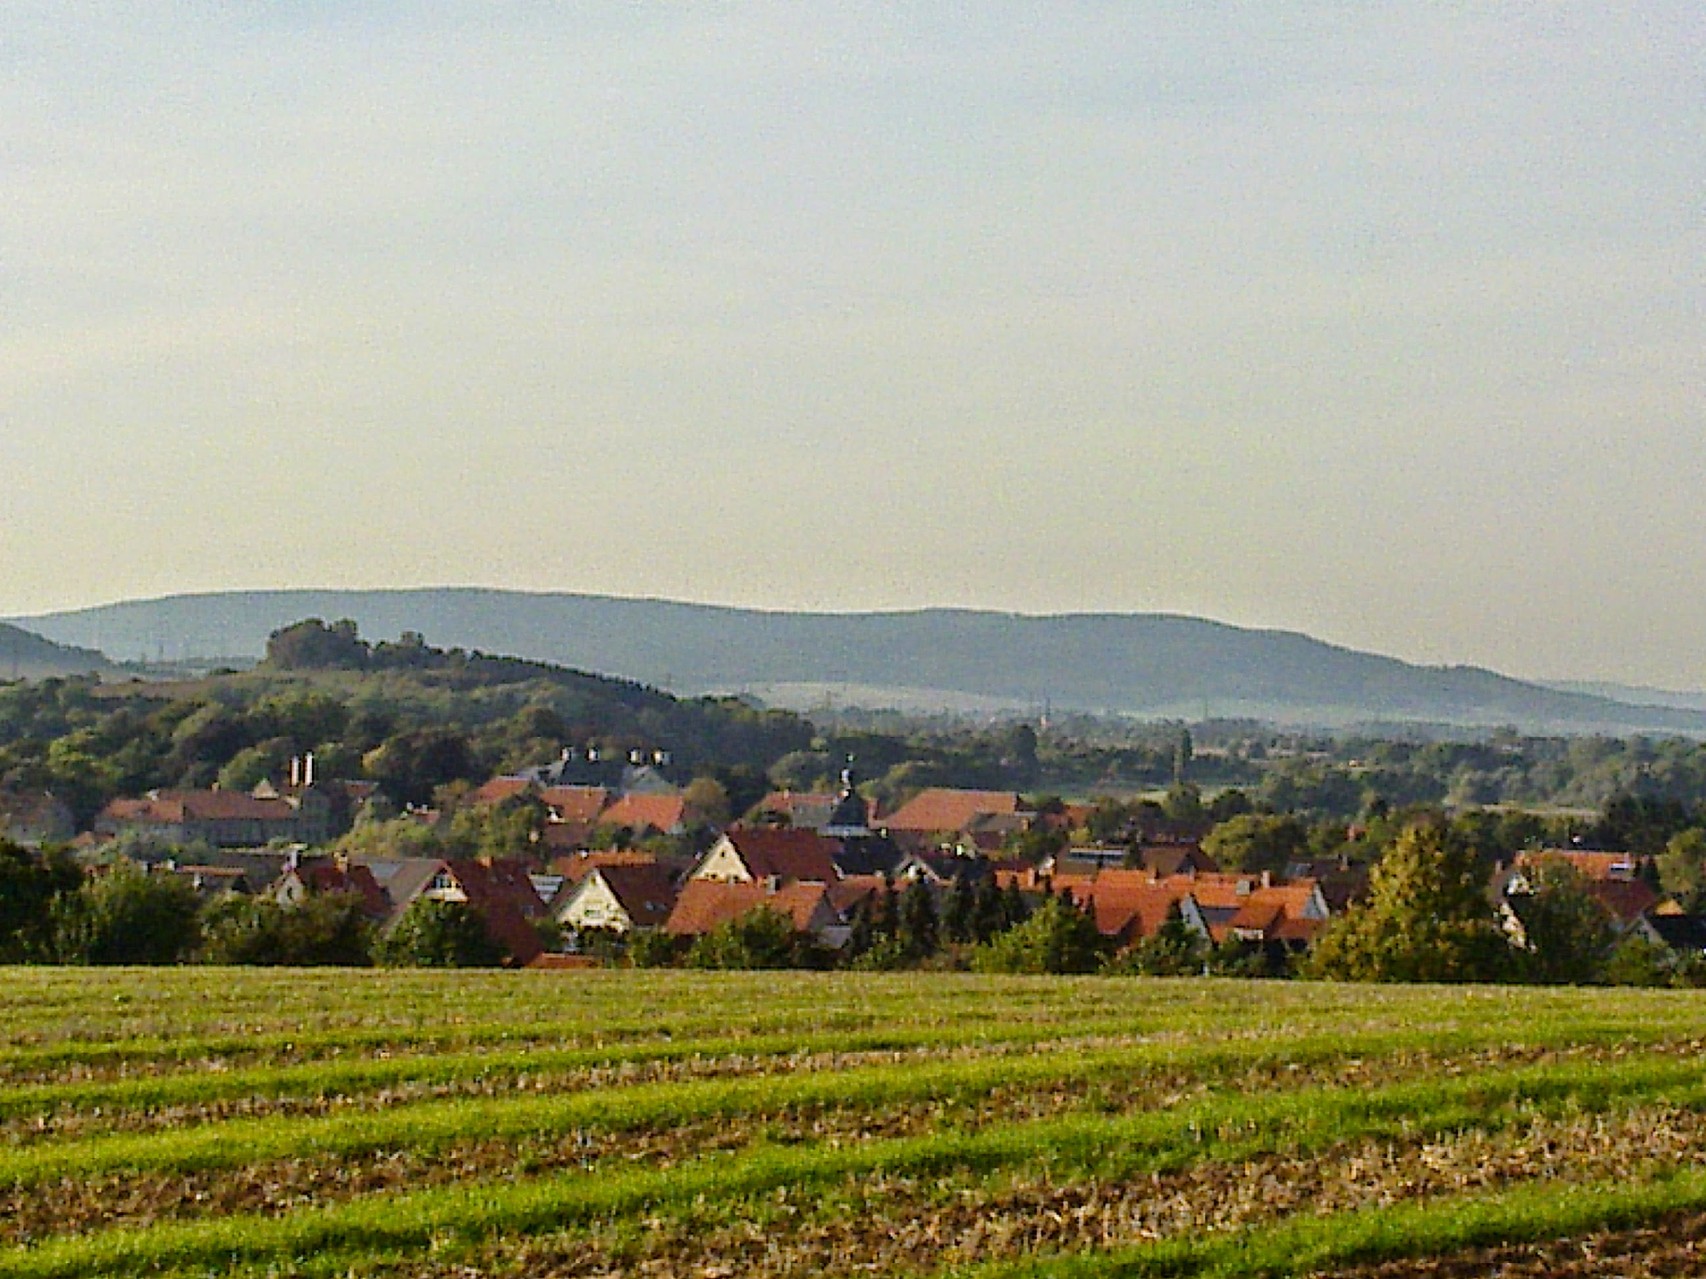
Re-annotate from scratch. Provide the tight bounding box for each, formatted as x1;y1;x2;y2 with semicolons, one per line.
0;0;1706;689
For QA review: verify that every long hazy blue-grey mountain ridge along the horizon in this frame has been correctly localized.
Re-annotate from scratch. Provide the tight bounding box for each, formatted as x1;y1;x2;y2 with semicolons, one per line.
14;588;1706;735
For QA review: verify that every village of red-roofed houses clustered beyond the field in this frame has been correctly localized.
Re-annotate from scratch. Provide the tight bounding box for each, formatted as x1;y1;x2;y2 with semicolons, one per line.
0;747;1706;977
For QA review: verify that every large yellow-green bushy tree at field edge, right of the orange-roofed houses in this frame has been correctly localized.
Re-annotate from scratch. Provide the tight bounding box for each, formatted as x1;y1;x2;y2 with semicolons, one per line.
1305;825;1510;982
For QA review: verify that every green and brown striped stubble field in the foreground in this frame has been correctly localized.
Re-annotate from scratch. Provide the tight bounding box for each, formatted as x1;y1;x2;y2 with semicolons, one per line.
10;969;1706;1279
